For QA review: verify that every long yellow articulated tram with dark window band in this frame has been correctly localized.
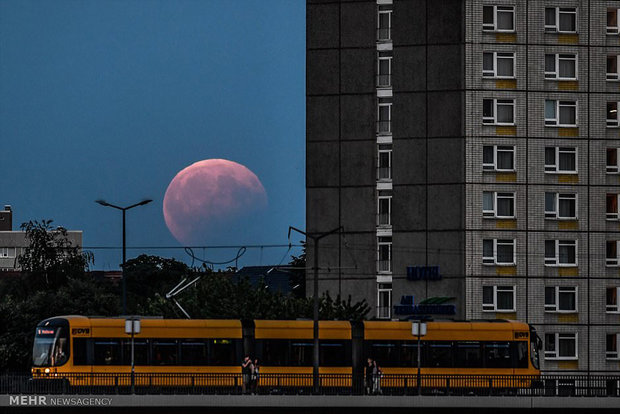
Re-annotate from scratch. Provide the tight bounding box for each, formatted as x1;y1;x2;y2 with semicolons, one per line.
32;315;541;387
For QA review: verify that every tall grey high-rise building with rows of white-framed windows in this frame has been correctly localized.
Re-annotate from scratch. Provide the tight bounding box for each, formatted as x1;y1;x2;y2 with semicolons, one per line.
306;0;620;372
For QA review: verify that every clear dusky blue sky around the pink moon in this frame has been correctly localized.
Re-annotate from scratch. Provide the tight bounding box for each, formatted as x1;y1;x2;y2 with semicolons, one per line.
0;0;305;269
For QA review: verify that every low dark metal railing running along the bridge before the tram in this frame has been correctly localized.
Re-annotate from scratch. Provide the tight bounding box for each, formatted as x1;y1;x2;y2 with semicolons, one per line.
0;373;620;397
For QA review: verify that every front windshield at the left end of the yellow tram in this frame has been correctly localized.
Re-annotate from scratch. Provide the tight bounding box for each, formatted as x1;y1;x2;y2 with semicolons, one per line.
32;323;69;367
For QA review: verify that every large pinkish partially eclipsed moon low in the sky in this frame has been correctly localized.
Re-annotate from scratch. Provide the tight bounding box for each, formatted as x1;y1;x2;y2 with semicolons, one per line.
164;159;267;246
